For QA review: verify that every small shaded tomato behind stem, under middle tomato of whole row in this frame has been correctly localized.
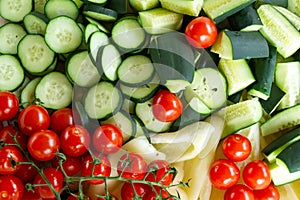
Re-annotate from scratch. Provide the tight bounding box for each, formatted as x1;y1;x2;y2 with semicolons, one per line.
51;156;82;176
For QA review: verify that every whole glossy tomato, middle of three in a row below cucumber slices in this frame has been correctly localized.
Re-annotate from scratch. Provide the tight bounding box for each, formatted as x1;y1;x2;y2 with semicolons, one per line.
60;125;91;157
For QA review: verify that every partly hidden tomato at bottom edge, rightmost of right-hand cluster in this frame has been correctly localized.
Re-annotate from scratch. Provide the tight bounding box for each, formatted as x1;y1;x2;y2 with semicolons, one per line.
253;183;280;200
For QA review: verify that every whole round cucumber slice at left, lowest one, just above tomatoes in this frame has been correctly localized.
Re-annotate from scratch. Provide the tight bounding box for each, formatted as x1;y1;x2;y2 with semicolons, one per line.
35;72;73;110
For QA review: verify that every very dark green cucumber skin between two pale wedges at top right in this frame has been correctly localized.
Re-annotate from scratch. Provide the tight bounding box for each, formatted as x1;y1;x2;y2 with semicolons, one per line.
228;4;262;31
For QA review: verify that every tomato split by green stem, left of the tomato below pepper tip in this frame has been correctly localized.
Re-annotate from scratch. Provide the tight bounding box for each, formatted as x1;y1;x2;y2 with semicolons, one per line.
81;154;111;184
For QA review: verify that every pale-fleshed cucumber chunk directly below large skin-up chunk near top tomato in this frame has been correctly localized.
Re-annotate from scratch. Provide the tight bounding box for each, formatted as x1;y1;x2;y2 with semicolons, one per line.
218;58;255;96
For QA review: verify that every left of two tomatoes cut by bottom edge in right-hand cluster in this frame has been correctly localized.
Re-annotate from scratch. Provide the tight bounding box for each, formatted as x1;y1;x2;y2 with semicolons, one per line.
224;184;254;200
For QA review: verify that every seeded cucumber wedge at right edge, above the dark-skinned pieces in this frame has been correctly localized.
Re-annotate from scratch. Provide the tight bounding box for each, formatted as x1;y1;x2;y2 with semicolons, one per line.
261;105;300;136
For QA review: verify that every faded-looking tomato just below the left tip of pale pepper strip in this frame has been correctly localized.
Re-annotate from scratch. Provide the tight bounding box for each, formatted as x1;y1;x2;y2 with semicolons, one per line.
117;153;147;180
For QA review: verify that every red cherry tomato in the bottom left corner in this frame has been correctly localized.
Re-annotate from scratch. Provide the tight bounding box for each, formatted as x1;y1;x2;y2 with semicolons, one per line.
0;175;24;200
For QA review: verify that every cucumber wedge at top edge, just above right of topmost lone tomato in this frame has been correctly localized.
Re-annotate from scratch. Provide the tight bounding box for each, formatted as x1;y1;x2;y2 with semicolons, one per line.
203;0;255;23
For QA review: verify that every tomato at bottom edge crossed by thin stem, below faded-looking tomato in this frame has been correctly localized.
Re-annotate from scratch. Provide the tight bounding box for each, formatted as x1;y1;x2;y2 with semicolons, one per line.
121;182;151;200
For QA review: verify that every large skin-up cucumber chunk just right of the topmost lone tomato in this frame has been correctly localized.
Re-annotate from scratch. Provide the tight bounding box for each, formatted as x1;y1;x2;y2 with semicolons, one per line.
211;30;269;60
